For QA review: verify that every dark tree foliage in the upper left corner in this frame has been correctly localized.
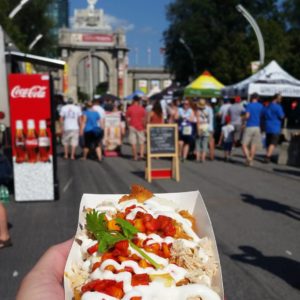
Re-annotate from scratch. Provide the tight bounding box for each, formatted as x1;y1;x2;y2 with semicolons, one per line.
0;0;57;56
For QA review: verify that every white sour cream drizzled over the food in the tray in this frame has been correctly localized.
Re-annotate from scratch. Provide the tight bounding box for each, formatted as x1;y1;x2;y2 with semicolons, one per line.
80;197;220;300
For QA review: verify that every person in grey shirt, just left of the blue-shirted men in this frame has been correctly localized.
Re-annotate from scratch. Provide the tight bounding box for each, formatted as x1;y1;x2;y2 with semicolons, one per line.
228;96;245;146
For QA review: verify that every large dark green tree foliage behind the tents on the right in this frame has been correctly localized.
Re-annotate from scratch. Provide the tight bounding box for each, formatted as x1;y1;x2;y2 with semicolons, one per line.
164;0;300;84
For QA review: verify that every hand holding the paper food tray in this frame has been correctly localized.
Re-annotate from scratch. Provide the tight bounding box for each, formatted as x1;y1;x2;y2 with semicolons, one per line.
16;239;73;300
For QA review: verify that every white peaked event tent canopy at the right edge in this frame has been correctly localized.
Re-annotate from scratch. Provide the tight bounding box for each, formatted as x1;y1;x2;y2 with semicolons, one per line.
222;60;300;98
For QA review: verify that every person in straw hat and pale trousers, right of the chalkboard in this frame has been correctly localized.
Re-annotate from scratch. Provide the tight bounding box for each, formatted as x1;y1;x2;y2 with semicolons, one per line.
196;99;210;162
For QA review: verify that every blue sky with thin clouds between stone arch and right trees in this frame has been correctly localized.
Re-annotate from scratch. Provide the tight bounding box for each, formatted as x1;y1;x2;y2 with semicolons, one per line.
69;0;172;67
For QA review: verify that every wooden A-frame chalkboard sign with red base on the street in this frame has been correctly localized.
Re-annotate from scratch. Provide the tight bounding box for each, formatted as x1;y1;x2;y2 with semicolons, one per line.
145;124;180;182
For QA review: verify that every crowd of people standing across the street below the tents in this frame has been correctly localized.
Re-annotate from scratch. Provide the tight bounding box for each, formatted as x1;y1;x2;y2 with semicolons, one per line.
59;94;284;166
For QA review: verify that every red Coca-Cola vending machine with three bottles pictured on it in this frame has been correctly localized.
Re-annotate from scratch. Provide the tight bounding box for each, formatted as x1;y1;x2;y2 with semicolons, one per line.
9;74;57;201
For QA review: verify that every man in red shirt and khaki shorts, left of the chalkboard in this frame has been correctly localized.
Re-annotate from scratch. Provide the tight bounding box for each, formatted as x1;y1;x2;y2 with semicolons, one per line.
126;96;147;160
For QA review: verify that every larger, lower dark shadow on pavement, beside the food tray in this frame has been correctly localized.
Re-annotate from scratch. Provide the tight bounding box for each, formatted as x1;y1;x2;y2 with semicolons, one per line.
230;246;300;290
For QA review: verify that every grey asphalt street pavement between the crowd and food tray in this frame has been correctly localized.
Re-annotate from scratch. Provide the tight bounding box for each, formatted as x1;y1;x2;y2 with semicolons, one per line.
0;146;300;300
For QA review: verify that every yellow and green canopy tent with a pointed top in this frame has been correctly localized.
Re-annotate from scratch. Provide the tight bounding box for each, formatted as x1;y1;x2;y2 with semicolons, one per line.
184;71;224;98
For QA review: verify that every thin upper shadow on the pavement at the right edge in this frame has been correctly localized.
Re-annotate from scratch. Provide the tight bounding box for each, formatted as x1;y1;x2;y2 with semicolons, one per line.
241;194;300;221
